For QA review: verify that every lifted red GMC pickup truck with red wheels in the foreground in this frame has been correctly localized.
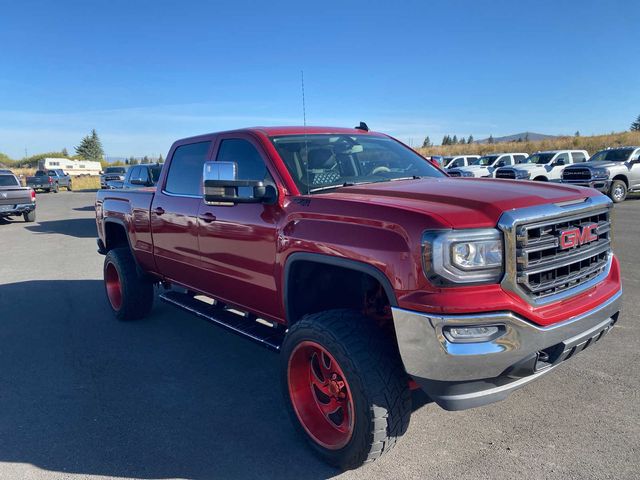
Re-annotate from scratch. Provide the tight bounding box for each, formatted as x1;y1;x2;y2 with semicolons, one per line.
96;125;622;468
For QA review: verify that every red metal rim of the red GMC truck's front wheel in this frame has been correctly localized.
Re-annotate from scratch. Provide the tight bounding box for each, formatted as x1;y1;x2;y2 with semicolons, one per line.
287;341;355;450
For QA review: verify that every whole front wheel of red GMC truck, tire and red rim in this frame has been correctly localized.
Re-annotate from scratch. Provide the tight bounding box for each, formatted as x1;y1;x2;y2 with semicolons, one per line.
281;310;411;469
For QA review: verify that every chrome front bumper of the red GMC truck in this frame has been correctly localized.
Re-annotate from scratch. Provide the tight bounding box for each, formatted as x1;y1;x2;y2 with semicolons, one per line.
393;291;622;410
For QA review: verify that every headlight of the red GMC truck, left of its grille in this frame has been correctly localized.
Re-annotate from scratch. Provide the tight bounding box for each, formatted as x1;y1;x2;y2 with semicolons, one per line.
422;229;504;285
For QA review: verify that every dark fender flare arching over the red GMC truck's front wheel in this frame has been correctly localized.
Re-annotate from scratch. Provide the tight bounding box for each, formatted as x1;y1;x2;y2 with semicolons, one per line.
283;252;398;322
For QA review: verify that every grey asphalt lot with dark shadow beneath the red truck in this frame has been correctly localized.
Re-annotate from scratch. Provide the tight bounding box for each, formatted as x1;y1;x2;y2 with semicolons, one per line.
0;192;640;480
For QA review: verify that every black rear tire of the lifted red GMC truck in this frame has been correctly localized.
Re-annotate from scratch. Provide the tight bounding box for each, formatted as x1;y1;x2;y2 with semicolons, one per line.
103;248;153;320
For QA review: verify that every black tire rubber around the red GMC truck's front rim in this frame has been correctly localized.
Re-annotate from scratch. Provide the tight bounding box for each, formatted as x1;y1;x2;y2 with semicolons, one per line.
281;310;411;470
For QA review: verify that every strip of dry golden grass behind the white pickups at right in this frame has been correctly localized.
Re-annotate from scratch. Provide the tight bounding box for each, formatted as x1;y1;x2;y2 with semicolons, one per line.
416;132;640;155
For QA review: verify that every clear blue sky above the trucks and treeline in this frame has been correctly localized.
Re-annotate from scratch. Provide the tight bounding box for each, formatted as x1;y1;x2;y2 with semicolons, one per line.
0;0;640;158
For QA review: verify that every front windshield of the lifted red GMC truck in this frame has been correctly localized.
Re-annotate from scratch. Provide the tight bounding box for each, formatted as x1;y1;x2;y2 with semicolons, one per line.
271;134;445;193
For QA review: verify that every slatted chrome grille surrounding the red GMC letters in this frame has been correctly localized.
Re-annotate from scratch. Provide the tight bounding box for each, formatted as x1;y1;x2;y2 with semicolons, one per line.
515;209;611;299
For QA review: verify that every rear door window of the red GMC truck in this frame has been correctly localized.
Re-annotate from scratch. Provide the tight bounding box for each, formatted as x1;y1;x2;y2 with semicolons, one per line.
164;142;211;195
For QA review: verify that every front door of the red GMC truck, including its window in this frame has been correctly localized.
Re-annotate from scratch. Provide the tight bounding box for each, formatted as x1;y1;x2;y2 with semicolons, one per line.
198;134;284;320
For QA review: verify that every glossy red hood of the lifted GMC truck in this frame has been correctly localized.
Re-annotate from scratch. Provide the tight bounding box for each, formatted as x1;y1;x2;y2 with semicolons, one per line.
318;178;601;228
